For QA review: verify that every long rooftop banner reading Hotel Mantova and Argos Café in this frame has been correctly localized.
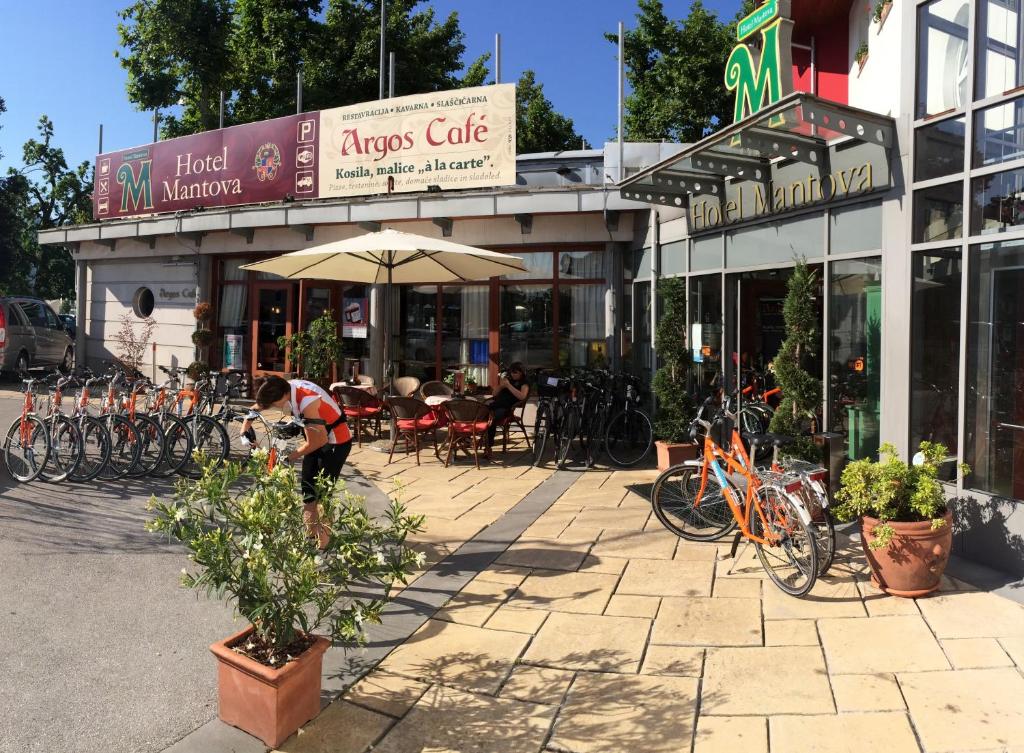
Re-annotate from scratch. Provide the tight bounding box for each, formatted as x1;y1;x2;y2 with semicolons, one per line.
92;84;515;220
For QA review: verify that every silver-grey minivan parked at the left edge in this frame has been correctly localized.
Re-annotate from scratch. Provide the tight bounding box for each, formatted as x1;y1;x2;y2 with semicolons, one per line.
0;297;75;374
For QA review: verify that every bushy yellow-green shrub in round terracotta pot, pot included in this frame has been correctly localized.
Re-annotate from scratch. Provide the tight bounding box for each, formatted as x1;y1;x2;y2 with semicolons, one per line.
833;442;970;597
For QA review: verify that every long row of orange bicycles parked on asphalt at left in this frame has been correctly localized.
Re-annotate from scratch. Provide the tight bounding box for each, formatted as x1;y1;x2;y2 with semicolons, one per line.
3;367;276;483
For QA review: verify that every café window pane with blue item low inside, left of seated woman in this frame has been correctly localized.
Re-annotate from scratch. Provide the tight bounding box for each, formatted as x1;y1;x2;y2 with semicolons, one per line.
441;285;490;384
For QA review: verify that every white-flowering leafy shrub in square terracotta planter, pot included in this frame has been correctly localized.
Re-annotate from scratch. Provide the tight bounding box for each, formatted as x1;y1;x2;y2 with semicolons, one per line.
146;451;423;748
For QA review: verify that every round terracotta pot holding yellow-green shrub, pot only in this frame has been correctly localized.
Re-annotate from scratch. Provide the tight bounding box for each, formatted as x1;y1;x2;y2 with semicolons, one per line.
860;511;953;598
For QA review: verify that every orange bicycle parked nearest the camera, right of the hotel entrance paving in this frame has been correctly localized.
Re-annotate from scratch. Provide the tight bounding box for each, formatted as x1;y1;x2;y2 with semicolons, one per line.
651;403;819;596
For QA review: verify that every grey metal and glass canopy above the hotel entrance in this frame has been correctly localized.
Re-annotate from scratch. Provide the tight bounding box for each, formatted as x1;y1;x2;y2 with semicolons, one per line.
618;91;896;215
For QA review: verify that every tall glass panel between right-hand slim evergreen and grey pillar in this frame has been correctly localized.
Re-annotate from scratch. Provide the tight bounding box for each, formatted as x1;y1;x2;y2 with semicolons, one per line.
828;257;882;460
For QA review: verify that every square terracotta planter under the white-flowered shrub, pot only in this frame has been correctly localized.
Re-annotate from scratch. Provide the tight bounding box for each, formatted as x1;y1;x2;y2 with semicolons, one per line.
210;627;331;748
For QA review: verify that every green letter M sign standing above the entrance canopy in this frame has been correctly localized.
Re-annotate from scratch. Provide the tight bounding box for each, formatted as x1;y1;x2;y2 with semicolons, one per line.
725;0;793;123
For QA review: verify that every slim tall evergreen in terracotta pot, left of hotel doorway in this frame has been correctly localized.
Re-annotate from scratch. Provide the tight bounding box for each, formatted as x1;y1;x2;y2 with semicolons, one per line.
651;278;698;470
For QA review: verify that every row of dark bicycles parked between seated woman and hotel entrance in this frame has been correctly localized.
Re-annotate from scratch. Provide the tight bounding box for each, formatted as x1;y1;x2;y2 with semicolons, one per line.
532;369;654;468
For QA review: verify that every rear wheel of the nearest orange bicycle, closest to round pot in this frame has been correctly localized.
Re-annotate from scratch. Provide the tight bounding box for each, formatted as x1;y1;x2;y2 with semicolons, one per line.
751;485;818;596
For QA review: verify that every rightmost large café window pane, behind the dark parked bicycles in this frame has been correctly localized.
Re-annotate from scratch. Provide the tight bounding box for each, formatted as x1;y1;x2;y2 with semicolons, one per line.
558;285;608;371
